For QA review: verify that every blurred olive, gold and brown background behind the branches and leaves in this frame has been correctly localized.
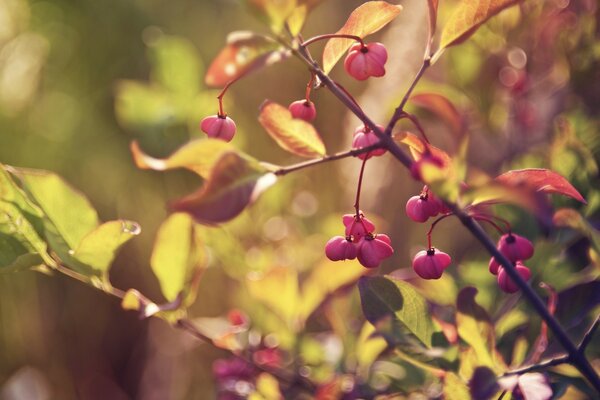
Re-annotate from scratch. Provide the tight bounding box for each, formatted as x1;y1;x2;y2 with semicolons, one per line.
0;0;600;399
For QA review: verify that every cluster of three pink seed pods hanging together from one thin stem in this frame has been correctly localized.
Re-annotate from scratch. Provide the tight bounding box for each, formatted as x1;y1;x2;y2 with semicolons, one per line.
325;213;394;268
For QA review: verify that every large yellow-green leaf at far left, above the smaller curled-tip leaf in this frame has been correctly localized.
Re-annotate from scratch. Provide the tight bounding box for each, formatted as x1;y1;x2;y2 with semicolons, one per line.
11;168;98;249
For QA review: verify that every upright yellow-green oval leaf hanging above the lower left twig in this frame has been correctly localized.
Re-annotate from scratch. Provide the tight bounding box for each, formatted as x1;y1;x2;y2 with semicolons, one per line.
150;213;205;305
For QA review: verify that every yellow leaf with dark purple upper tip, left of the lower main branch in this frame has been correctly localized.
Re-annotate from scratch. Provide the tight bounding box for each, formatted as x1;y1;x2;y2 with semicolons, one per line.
456;287;498;369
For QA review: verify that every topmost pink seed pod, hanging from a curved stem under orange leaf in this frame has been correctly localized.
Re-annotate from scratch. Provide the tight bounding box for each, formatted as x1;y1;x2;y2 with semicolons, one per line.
344;43;388;81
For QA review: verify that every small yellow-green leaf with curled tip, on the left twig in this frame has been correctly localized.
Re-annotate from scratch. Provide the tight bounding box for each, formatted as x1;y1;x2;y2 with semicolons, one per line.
73;220;141;276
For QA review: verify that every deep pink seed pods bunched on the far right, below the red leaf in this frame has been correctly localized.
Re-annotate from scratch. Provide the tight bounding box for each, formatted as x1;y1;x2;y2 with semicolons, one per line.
489;233;533;293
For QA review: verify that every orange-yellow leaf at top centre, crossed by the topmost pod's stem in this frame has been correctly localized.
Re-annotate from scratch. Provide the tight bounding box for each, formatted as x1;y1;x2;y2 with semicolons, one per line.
323;1;402;74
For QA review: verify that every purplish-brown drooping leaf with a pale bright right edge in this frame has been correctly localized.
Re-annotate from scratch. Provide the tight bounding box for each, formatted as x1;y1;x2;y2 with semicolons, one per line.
171;152;277;224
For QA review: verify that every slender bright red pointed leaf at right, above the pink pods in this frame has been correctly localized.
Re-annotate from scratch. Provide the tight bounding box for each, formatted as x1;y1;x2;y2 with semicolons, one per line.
496;168;587;204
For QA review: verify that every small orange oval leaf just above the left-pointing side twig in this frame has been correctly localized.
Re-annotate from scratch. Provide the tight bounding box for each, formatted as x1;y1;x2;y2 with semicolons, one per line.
258;100;325;157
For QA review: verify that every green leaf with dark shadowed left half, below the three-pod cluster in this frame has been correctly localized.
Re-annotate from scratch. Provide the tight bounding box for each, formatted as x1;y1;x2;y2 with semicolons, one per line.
358;276;434;347
